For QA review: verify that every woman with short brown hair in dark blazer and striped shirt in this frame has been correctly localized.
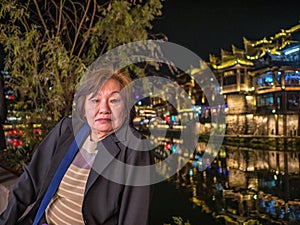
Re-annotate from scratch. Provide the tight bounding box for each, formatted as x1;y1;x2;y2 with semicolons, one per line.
0;69;153;225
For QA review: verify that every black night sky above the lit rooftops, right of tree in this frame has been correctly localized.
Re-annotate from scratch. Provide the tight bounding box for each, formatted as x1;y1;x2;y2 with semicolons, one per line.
153;0;300;60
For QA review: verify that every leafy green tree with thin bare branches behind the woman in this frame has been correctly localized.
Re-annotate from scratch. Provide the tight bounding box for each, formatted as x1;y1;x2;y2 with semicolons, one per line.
0;0;163;122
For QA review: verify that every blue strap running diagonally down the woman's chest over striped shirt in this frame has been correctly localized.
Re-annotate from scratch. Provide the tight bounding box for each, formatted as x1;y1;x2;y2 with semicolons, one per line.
33;124;90;225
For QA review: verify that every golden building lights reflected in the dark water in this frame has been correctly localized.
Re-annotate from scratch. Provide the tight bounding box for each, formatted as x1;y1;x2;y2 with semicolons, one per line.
156;138;300;224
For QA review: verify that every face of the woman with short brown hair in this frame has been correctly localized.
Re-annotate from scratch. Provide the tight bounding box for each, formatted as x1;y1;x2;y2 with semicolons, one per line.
85;79;126;141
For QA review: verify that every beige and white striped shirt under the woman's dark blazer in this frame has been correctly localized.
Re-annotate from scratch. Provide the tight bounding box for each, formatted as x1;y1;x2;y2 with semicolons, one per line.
46;137;97;225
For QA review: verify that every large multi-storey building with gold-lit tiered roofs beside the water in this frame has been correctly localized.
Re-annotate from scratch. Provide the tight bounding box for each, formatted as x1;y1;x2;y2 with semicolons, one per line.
208;24;300;136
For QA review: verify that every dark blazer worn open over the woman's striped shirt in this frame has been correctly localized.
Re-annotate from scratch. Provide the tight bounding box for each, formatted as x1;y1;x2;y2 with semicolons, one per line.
0;118;153;225
